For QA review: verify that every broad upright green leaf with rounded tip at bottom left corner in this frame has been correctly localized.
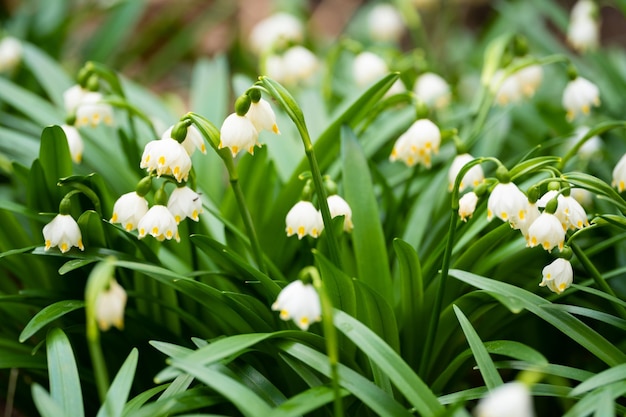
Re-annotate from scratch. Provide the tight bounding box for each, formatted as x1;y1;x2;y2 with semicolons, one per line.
46;328;84;417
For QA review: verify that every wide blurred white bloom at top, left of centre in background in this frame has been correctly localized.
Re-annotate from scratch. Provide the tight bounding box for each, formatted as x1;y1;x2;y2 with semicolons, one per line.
250;13;304;54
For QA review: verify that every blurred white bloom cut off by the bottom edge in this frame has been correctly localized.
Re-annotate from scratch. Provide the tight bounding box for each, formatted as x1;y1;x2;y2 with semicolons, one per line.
474;382;535;417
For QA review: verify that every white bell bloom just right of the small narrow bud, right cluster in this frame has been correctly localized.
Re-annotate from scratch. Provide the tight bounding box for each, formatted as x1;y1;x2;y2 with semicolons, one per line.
487;182;528;228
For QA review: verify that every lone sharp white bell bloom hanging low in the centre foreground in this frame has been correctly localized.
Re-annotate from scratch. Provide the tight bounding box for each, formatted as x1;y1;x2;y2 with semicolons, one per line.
272;280;322;330
